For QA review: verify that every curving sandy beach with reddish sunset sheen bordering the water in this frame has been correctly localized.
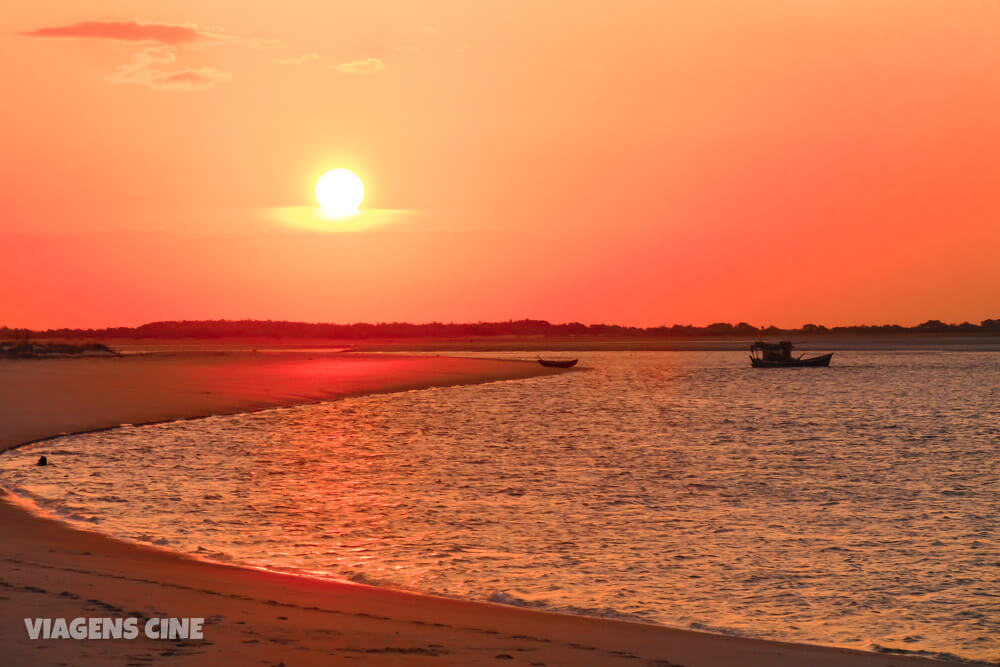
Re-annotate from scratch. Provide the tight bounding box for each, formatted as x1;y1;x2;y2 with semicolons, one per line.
0;351;968;667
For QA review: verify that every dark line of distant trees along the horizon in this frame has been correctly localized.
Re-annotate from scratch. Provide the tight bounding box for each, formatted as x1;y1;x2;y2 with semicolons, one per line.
0;319;1000;340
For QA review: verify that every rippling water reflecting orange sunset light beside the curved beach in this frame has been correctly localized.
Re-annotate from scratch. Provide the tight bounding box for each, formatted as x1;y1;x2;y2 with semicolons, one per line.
0;352;1000;660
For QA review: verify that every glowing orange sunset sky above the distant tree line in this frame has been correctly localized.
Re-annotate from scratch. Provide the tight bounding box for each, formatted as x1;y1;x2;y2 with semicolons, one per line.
0;0;1000;328
